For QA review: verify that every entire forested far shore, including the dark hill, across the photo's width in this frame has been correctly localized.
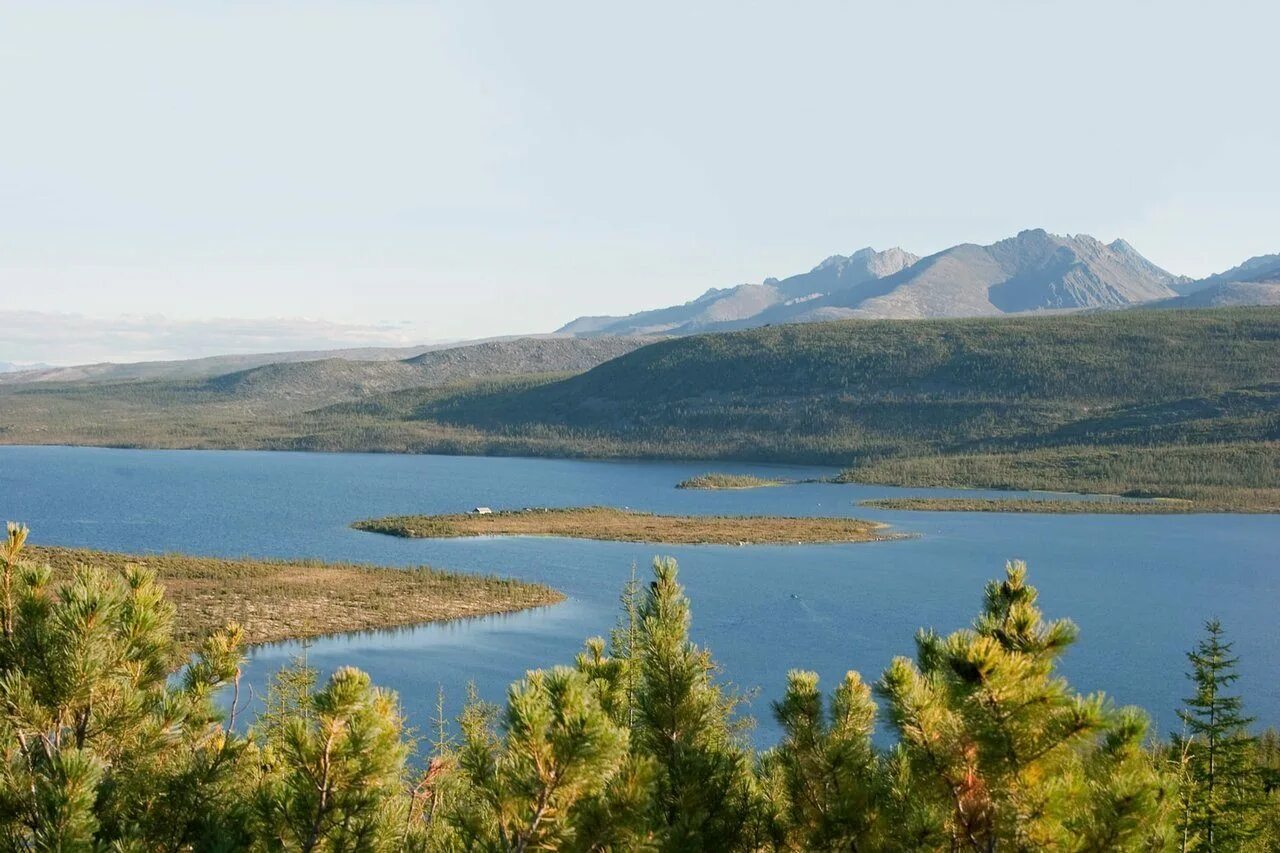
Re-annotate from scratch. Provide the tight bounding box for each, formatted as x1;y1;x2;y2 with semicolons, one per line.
0;307;1280;502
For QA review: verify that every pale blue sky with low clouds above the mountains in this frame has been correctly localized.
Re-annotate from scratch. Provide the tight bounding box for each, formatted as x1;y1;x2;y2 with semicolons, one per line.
0;0;1280;364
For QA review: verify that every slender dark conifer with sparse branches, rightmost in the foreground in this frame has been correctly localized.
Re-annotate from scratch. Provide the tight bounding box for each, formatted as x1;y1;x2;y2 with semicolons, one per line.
1172;619;1263;853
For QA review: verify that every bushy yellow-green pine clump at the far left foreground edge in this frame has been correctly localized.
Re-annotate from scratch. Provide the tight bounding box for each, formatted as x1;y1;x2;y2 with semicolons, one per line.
0;525;243;849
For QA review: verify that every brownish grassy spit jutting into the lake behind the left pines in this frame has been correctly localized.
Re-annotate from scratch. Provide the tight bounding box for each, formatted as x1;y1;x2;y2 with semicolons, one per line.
26;546;564;648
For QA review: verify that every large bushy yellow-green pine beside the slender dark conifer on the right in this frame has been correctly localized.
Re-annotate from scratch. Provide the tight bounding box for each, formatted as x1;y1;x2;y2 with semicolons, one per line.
878;564;1167;850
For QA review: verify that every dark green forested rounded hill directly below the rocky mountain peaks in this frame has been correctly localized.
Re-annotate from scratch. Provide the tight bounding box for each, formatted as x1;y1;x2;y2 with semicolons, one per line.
435;309;1280;459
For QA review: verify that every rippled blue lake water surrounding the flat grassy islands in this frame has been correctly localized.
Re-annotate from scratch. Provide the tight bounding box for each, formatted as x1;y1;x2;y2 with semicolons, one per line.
0;447;1280;744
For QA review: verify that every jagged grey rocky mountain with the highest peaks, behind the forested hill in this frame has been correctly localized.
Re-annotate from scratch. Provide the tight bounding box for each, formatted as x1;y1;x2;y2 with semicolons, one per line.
559;229;1189;336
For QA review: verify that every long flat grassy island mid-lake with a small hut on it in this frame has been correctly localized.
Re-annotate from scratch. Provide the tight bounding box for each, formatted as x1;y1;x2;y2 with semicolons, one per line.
352;506;891;544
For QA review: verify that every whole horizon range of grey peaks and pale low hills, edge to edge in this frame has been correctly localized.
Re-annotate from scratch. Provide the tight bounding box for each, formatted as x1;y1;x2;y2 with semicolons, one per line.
0;229;1280;384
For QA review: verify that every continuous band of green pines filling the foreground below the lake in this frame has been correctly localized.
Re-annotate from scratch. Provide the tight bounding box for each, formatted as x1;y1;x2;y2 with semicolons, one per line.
0;526;1280;853
